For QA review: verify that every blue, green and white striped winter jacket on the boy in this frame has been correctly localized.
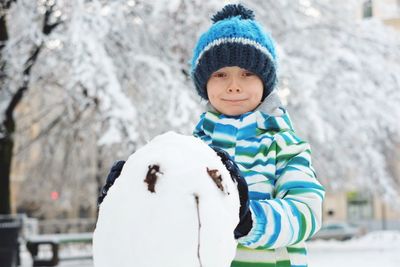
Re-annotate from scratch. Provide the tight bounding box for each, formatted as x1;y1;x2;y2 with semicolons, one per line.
194;92;325;267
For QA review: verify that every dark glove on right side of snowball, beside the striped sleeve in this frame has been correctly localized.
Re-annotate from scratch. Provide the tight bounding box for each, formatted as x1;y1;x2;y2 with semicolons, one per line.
211;146;253;239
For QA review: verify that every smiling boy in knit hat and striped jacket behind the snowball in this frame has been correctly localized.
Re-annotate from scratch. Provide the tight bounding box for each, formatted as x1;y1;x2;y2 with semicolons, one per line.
99;5;324;267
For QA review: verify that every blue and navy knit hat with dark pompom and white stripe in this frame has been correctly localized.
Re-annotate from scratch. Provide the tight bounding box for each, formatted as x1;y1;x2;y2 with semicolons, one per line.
190;4;277;100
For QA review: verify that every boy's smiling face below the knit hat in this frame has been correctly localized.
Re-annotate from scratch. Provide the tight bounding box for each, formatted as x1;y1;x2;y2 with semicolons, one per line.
207;66;264;116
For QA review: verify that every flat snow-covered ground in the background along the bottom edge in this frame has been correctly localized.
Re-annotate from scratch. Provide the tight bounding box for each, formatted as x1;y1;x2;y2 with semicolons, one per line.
22;231;400;267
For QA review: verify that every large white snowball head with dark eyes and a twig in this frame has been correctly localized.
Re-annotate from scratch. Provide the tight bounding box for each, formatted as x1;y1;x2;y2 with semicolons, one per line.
93;132;239;267
